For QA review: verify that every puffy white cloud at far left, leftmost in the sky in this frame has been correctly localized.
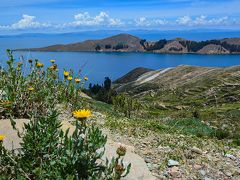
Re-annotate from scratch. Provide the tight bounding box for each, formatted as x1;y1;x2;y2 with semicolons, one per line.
0;14;51;30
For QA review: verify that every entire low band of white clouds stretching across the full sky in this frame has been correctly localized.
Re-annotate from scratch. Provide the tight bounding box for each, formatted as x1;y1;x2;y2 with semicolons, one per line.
0;12;240;31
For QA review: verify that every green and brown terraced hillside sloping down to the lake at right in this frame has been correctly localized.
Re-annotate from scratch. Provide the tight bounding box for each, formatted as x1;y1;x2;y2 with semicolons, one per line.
114;66;240;129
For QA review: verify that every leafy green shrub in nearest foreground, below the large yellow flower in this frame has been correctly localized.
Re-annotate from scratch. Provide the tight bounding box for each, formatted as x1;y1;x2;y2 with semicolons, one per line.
0;111;130;179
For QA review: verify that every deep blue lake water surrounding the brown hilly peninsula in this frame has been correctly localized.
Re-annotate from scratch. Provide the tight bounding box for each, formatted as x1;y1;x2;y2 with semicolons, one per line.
0;35;240;83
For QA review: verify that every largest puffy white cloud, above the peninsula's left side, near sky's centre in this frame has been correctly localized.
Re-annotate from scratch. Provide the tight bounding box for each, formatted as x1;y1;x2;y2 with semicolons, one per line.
69;12;123;26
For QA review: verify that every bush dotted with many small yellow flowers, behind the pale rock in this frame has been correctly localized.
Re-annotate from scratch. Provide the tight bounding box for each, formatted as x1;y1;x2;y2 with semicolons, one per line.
0;50;83;118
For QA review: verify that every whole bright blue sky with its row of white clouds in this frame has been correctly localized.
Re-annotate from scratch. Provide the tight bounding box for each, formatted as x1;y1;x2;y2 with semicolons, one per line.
0;0;240;34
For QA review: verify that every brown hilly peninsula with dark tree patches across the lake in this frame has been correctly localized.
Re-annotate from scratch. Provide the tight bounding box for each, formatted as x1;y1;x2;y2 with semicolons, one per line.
16;34;240;54
